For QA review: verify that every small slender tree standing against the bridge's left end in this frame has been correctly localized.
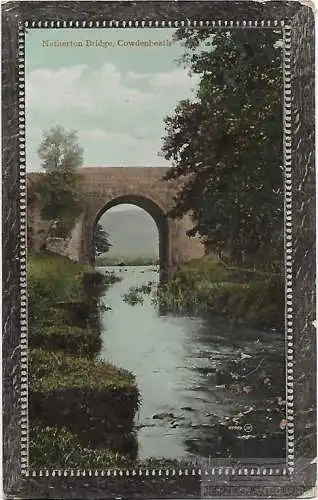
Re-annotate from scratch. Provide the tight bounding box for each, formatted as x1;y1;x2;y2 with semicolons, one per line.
38;126;83;238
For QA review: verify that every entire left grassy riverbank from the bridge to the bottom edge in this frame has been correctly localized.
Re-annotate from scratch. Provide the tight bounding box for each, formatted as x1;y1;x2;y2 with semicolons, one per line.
28;253;139;468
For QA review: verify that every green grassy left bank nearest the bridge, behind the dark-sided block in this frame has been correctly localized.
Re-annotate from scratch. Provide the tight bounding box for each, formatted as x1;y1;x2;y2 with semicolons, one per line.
28;252;102;356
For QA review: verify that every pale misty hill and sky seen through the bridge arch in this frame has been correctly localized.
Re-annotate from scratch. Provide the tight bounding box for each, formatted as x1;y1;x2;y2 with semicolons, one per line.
99;206;159;261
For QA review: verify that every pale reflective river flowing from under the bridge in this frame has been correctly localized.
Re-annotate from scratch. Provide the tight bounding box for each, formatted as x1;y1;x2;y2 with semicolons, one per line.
97;266;284;459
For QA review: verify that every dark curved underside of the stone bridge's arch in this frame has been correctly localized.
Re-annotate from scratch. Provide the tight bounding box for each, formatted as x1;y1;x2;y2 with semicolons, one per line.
90;195;170;282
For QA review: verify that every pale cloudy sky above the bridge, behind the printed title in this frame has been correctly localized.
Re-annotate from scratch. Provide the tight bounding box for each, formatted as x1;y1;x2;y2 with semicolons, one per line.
26;28;196;171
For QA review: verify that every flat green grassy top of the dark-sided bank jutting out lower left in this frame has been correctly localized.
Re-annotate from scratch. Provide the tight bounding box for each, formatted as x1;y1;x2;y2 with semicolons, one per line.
29;349;136;392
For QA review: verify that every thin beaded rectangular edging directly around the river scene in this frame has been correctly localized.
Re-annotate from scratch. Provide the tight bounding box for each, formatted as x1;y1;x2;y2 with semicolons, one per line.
19;19;294;478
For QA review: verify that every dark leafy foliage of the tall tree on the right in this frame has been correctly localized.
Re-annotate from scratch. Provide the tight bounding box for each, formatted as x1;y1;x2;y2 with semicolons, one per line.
162;28;283;267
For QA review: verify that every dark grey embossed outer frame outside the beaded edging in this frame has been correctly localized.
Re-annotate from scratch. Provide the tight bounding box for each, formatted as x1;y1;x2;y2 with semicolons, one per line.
3;2;315;498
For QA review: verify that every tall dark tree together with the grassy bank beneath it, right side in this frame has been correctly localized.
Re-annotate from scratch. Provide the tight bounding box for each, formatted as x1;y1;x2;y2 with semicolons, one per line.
159;27;284;327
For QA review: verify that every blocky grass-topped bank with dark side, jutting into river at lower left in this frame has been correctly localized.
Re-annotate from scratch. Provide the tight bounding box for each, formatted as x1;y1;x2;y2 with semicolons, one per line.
29;349;139;452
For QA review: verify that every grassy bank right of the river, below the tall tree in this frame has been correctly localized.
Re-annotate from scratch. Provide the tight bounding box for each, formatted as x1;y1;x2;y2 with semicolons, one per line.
156;259;284;328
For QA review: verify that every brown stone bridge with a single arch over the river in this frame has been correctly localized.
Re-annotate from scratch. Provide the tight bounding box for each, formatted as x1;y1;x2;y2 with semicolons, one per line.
28;167;204;275
